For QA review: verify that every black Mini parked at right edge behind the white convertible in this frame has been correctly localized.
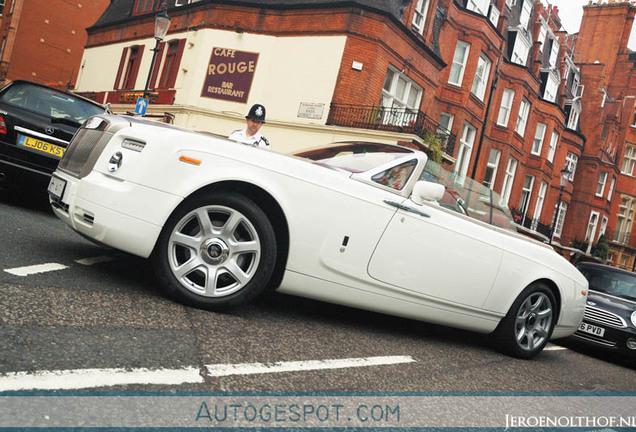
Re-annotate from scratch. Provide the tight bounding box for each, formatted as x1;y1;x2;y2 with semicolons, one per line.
574;262;636;357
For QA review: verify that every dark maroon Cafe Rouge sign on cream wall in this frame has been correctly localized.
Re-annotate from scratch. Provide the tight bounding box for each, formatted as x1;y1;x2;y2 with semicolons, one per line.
201;47;258;103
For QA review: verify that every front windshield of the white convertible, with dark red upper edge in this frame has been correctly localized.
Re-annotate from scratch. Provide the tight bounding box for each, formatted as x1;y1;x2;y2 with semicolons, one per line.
295;143;413;173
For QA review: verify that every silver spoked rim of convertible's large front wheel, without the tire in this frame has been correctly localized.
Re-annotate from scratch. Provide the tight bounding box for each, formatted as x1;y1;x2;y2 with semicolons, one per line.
167;205;262;298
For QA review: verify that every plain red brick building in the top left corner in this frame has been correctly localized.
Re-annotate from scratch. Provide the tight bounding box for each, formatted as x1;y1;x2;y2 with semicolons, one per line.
0;0;110;88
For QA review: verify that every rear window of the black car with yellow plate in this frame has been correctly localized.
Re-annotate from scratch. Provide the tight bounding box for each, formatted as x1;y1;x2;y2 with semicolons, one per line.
0;83;105;126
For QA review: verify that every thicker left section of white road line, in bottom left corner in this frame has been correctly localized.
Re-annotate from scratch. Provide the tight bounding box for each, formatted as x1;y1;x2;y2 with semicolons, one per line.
0;367;203;391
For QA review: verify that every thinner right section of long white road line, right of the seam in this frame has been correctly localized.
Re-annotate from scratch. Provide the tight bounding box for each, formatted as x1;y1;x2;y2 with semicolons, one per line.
205;356;415;377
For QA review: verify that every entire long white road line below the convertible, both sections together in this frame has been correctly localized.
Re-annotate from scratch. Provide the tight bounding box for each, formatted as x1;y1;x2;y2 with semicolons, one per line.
0;356;416;392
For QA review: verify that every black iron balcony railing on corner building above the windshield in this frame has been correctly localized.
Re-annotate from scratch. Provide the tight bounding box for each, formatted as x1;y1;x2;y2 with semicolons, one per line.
327;103;457;156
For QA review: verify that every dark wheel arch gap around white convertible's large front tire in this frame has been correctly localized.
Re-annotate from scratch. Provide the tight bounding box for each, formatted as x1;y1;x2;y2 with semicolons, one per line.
173;180;289;290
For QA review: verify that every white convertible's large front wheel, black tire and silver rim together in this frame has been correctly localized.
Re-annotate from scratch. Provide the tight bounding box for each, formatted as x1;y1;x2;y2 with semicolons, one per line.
151;192;276;311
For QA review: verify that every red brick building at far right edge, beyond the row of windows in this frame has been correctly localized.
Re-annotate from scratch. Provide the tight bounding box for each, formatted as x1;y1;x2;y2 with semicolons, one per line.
569;1;636;271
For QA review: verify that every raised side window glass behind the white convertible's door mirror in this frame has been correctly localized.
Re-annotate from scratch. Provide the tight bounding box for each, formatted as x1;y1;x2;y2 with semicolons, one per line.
420;160;517;231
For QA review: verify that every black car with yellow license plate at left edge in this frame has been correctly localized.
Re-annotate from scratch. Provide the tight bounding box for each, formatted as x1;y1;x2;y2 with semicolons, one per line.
0;80;107;179
